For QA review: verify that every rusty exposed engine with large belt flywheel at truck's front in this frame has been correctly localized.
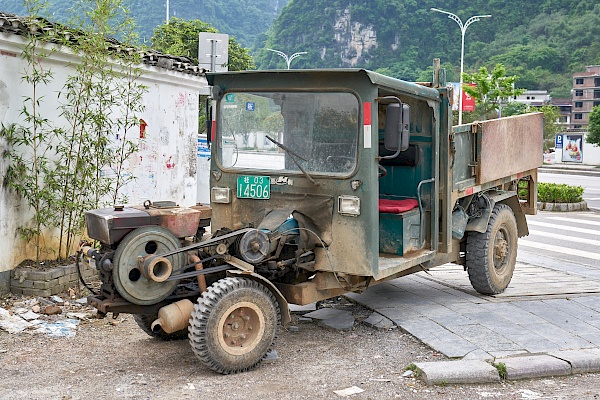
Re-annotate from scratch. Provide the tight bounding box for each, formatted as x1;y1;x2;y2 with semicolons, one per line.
82;201;314;316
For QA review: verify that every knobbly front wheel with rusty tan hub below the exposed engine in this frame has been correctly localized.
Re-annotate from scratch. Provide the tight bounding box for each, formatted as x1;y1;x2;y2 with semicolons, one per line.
188;277;281;374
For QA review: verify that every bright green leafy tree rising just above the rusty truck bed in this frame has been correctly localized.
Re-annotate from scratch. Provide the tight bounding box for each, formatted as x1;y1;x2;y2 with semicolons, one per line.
463;64;525;120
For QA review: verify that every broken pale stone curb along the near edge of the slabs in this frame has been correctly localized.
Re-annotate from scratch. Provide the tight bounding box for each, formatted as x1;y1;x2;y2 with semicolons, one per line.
415;348;600;386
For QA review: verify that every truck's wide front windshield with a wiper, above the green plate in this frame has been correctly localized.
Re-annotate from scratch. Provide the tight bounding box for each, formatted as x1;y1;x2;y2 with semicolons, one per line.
218;92;359;175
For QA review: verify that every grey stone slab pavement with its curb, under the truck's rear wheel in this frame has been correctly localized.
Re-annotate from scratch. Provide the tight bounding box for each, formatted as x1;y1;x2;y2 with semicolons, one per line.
346;263;600;383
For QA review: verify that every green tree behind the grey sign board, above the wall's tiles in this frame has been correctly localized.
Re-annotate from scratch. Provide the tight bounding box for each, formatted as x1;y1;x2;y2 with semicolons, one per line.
150;18;256;71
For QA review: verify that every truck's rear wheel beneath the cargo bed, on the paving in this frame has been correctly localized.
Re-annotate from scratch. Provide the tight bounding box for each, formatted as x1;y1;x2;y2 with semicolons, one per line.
467;204;518;294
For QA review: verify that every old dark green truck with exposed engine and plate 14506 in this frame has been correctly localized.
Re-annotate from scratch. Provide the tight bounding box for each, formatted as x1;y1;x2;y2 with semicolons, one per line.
81;61;542;374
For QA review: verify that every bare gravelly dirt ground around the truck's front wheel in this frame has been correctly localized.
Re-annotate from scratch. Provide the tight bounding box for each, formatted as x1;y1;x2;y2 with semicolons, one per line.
0;296;600;400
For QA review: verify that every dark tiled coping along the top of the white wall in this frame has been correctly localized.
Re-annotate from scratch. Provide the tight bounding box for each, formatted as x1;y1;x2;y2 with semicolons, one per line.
0;12;206;75
